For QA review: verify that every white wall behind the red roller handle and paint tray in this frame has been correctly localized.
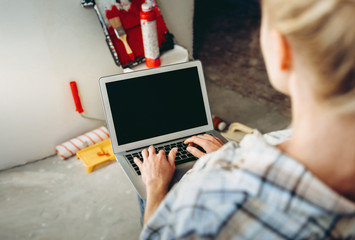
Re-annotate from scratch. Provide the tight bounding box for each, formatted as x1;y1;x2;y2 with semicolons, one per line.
0;0;193;169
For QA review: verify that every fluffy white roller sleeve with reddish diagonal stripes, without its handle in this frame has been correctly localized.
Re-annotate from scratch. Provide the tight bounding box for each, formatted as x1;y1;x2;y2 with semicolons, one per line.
55;127;110;159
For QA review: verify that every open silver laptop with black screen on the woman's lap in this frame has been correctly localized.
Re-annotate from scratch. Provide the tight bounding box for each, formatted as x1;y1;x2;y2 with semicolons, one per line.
99;61;228;199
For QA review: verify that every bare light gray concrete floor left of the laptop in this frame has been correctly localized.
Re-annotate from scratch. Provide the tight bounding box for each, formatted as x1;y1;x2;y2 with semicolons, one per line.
0;156;141;240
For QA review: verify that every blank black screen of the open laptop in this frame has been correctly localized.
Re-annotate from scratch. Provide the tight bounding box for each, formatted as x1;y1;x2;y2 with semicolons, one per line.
106;67;207;145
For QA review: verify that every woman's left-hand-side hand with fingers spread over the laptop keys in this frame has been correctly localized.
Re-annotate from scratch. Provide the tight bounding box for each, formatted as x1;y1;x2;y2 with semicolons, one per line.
134;146;177;192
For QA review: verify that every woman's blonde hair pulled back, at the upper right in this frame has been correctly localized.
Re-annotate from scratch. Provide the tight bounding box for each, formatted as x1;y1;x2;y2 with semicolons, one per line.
263;0;355;113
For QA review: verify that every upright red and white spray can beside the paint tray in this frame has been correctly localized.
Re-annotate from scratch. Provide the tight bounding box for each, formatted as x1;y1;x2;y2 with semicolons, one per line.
140;3;160;68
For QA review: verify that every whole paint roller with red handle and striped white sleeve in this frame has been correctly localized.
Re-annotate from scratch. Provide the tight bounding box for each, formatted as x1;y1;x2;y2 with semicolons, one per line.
55;81;110;159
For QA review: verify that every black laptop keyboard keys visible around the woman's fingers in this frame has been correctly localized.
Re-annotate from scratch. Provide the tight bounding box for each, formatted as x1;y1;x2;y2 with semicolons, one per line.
125;141;197;175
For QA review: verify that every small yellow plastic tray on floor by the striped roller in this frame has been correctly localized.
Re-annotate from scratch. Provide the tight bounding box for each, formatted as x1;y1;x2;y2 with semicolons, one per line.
76;138;116;173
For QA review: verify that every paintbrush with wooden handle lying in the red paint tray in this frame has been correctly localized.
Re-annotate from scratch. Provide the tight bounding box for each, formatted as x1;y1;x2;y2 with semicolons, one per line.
106;5;135;62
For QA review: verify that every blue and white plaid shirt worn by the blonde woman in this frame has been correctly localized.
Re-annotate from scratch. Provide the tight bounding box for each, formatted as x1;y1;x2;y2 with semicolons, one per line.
141;132;355;239
